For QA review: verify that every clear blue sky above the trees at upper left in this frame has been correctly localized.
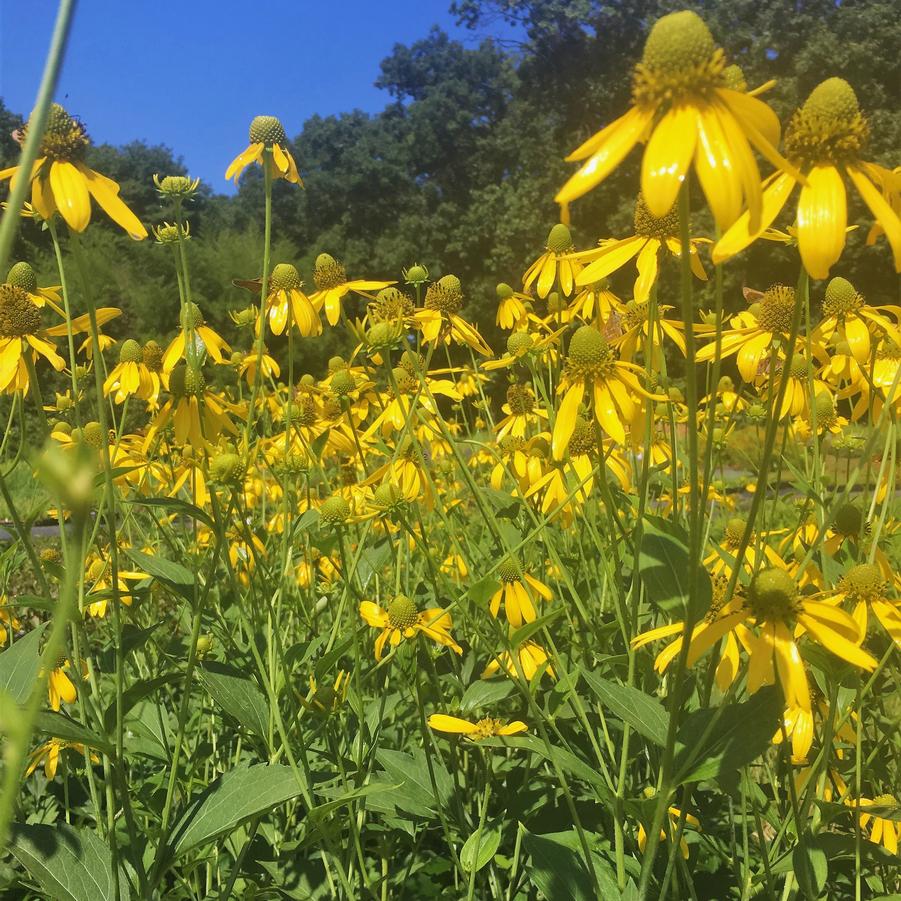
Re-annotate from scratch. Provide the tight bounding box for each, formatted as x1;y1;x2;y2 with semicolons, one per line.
0;0;509;191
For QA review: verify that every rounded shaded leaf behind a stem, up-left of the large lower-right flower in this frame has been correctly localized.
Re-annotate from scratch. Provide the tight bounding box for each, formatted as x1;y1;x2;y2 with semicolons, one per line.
638;517;713;618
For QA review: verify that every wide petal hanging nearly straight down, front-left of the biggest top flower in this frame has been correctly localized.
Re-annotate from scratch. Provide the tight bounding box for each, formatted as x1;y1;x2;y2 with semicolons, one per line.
641;106;698;219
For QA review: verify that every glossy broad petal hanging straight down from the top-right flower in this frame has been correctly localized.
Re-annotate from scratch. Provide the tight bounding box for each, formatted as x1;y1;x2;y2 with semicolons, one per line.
798;166;848;279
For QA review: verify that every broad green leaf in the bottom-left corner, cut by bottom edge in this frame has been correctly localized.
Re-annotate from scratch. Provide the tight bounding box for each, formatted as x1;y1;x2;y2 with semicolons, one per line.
9;823;131;901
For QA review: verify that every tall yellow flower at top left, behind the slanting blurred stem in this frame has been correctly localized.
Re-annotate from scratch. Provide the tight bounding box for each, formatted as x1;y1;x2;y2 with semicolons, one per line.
0;103;147;240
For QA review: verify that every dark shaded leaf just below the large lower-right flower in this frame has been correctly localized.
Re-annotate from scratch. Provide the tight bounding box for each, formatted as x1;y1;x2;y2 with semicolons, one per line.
673;685;782;784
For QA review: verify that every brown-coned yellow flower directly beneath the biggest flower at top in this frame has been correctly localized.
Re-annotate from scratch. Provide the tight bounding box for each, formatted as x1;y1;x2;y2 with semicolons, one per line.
573;194;707;303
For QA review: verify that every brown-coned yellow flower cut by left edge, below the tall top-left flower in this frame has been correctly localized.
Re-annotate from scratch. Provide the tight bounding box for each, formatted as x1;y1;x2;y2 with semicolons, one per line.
0;284;66;393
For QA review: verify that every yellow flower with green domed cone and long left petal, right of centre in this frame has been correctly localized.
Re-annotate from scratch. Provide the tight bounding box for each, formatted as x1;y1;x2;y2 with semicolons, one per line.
551;325;652;460
